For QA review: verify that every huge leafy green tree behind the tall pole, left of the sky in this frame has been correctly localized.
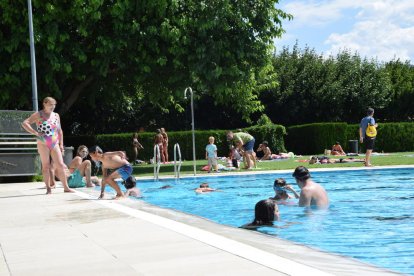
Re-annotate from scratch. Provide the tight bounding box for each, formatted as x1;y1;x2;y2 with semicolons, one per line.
0;0;291;132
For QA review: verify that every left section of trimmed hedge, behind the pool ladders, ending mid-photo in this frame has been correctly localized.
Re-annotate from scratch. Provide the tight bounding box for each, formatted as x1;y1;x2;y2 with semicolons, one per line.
64;124;286;161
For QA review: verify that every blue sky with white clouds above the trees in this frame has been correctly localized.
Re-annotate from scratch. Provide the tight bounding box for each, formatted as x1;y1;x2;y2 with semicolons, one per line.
275;0;414;64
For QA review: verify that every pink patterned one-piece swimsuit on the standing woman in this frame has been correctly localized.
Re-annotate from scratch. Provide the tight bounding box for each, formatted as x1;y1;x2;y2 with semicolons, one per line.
36;111;60;150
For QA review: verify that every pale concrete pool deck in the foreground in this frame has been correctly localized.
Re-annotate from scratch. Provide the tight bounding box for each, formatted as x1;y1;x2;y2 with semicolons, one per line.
0;166;406;275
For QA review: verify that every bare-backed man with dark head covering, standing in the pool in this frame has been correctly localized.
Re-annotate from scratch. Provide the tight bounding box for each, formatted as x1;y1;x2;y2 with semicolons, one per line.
292;166;329;208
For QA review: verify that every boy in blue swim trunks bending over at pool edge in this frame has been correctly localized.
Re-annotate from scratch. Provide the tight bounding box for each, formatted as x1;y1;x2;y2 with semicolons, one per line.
89;146;132;199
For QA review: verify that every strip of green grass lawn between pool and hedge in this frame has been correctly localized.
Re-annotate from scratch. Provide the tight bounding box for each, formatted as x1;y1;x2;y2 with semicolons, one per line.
133;152;414;177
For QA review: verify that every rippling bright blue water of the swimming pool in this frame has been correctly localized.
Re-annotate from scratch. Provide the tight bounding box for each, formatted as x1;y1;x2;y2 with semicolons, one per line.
119;169;414;274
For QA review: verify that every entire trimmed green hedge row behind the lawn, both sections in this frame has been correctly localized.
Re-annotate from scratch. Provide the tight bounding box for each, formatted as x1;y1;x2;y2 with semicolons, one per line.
65;123;414;160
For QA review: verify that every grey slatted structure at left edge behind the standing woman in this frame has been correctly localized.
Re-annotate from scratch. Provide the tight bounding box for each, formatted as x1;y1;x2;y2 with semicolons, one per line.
0;110;41;177
